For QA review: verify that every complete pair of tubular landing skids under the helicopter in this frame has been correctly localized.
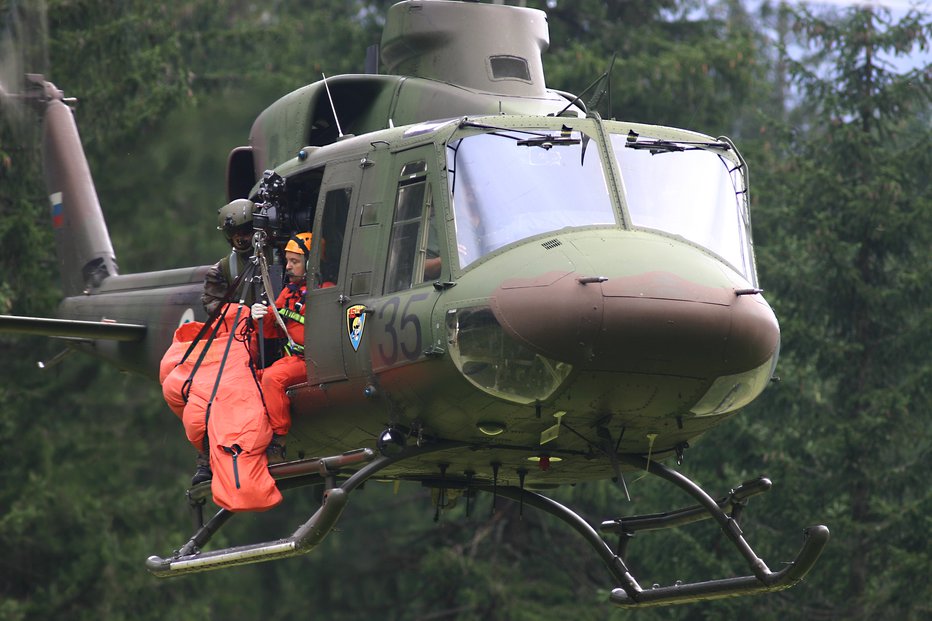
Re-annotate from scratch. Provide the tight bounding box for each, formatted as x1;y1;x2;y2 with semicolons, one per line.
146;443;829;608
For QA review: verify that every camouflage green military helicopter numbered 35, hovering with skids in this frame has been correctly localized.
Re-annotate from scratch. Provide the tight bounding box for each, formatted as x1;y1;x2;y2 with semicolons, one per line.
0;0;829;607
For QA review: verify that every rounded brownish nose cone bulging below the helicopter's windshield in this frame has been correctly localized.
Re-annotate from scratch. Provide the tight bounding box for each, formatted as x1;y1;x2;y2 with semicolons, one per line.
491;272;780;378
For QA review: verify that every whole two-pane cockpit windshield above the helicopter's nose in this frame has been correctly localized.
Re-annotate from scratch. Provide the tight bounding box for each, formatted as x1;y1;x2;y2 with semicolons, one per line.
447;122;756;284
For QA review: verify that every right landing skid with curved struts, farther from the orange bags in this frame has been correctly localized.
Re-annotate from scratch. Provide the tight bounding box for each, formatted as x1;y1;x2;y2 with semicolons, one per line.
473;455;829;608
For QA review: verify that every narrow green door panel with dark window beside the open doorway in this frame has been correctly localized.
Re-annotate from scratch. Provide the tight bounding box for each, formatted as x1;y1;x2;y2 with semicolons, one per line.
304;160;362;384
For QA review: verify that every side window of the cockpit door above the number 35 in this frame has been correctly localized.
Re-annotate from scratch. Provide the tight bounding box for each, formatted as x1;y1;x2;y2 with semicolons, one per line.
385;160;441;293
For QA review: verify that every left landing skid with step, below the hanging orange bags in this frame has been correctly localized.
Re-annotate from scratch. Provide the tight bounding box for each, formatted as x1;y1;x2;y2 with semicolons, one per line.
146;443;462;578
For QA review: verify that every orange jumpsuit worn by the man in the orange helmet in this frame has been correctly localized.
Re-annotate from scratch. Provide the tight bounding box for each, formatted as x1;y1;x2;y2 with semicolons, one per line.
255;284;307;436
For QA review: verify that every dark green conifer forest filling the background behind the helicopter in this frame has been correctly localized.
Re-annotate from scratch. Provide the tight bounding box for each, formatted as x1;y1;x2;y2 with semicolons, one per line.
0;0;932;621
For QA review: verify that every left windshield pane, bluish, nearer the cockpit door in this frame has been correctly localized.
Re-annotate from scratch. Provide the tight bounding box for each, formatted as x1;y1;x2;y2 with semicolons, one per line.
447;128;616;267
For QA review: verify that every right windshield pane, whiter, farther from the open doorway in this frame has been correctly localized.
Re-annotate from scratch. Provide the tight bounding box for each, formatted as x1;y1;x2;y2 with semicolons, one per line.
612;132;755;282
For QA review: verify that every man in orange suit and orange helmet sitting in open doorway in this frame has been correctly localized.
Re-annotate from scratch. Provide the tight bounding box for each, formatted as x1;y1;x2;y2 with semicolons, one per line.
252;233;311;460
